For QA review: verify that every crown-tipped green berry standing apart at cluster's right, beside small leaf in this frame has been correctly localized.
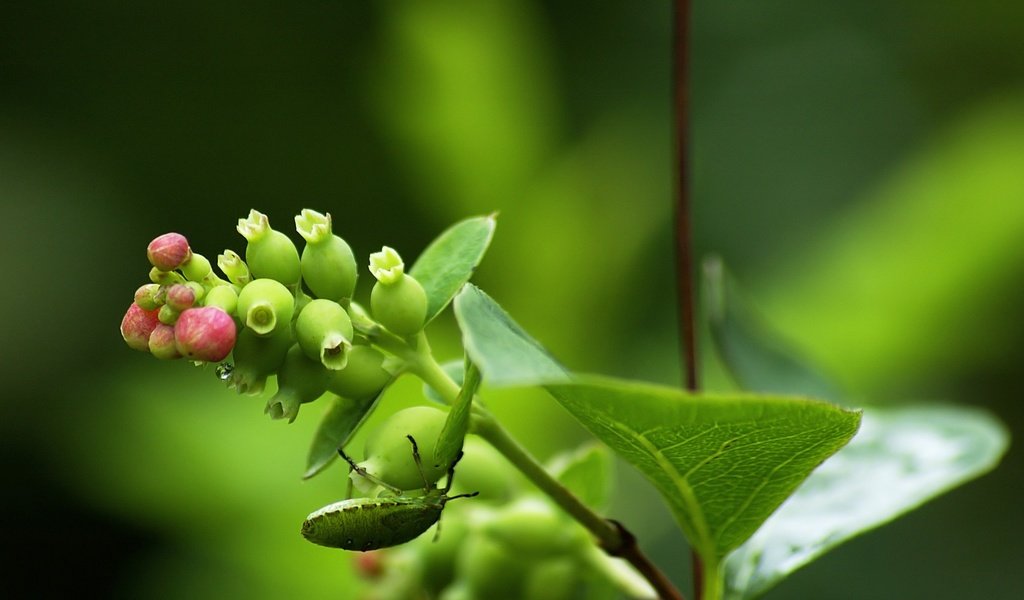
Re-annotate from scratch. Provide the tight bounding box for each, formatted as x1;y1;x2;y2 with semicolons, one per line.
370;246;427;336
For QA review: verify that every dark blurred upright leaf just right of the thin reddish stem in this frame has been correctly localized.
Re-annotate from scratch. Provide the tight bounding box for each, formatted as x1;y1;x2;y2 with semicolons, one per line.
703;257;844;401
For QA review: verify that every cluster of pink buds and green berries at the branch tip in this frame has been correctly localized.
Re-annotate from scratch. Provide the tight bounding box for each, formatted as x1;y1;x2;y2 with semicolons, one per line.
121;209;427;421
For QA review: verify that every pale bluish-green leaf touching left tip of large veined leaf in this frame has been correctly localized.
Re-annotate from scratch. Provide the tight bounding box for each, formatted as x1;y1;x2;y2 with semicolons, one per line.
455;284;568;387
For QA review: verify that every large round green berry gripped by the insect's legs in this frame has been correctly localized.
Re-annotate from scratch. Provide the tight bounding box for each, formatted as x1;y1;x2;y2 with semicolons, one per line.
352;406;449;489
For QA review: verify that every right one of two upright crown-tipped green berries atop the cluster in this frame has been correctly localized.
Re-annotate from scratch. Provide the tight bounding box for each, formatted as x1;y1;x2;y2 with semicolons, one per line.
295;209;357;302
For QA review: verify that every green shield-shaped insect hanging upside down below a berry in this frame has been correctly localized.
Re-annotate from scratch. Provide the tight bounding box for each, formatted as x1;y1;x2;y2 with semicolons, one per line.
302;435;479;552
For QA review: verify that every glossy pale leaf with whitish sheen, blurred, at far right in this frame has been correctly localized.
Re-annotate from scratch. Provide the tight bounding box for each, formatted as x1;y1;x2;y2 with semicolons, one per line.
725;405;1009;600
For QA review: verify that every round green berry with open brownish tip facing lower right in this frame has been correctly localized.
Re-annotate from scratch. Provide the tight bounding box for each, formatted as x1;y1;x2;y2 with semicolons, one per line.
296;296;353;371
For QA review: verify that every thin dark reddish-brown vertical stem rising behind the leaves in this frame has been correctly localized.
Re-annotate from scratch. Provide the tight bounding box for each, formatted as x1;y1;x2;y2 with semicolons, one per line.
672;0;706;600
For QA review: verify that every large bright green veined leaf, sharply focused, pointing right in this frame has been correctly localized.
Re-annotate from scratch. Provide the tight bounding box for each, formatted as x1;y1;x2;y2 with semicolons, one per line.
548;379;860;563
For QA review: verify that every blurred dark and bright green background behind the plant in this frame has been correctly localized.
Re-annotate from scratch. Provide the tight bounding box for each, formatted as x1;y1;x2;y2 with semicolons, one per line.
0;0;1024;599
